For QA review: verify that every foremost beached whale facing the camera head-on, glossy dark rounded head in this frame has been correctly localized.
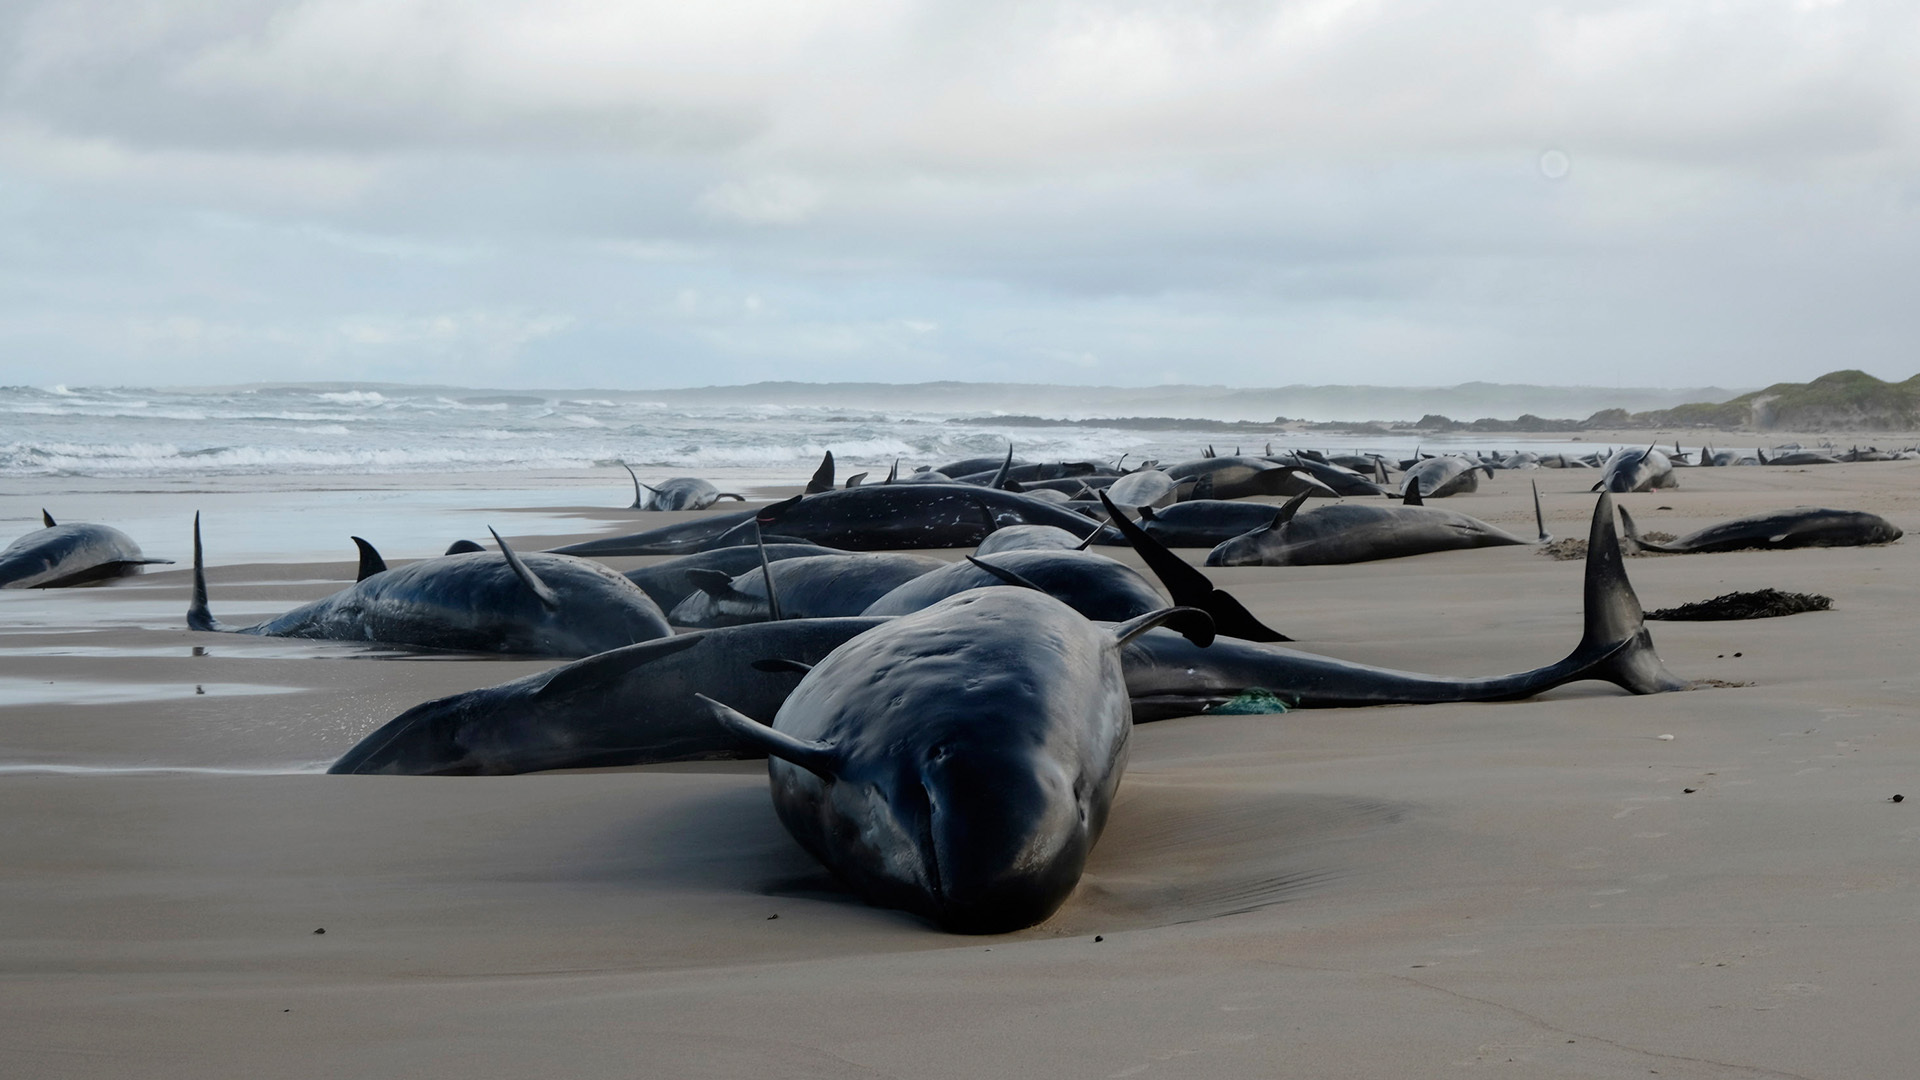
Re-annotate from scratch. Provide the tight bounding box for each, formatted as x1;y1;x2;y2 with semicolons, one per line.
714;588;1212;934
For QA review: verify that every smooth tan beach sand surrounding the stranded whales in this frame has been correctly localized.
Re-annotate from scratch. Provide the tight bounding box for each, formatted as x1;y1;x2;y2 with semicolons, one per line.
0;449;1920;1080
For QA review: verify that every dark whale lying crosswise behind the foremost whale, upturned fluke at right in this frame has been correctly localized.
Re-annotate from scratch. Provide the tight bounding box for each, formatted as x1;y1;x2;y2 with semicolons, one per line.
318;498;1686;776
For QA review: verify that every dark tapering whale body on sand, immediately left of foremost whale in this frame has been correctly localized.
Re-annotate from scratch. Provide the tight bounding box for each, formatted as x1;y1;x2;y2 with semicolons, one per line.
328;619;881;776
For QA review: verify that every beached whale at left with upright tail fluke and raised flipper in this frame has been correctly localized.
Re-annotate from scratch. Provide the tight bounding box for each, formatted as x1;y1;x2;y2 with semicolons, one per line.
186;515;674;657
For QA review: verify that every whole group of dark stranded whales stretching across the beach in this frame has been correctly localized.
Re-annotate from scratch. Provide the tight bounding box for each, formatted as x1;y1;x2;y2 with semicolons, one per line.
11;454;1899;932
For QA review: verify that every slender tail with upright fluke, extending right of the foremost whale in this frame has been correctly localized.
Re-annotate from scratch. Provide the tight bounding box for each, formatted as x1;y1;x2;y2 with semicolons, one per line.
1123;494;1690;723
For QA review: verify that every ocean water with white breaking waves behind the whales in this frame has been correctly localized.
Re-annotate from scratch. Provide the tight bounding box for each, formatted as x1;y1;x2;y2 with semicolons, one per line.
0;378;1620;480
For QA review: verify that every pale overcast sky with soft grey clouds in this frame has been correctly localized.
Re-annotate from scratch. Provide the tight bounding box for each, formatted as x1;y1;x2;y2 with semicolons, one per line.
0;0;1920;388
